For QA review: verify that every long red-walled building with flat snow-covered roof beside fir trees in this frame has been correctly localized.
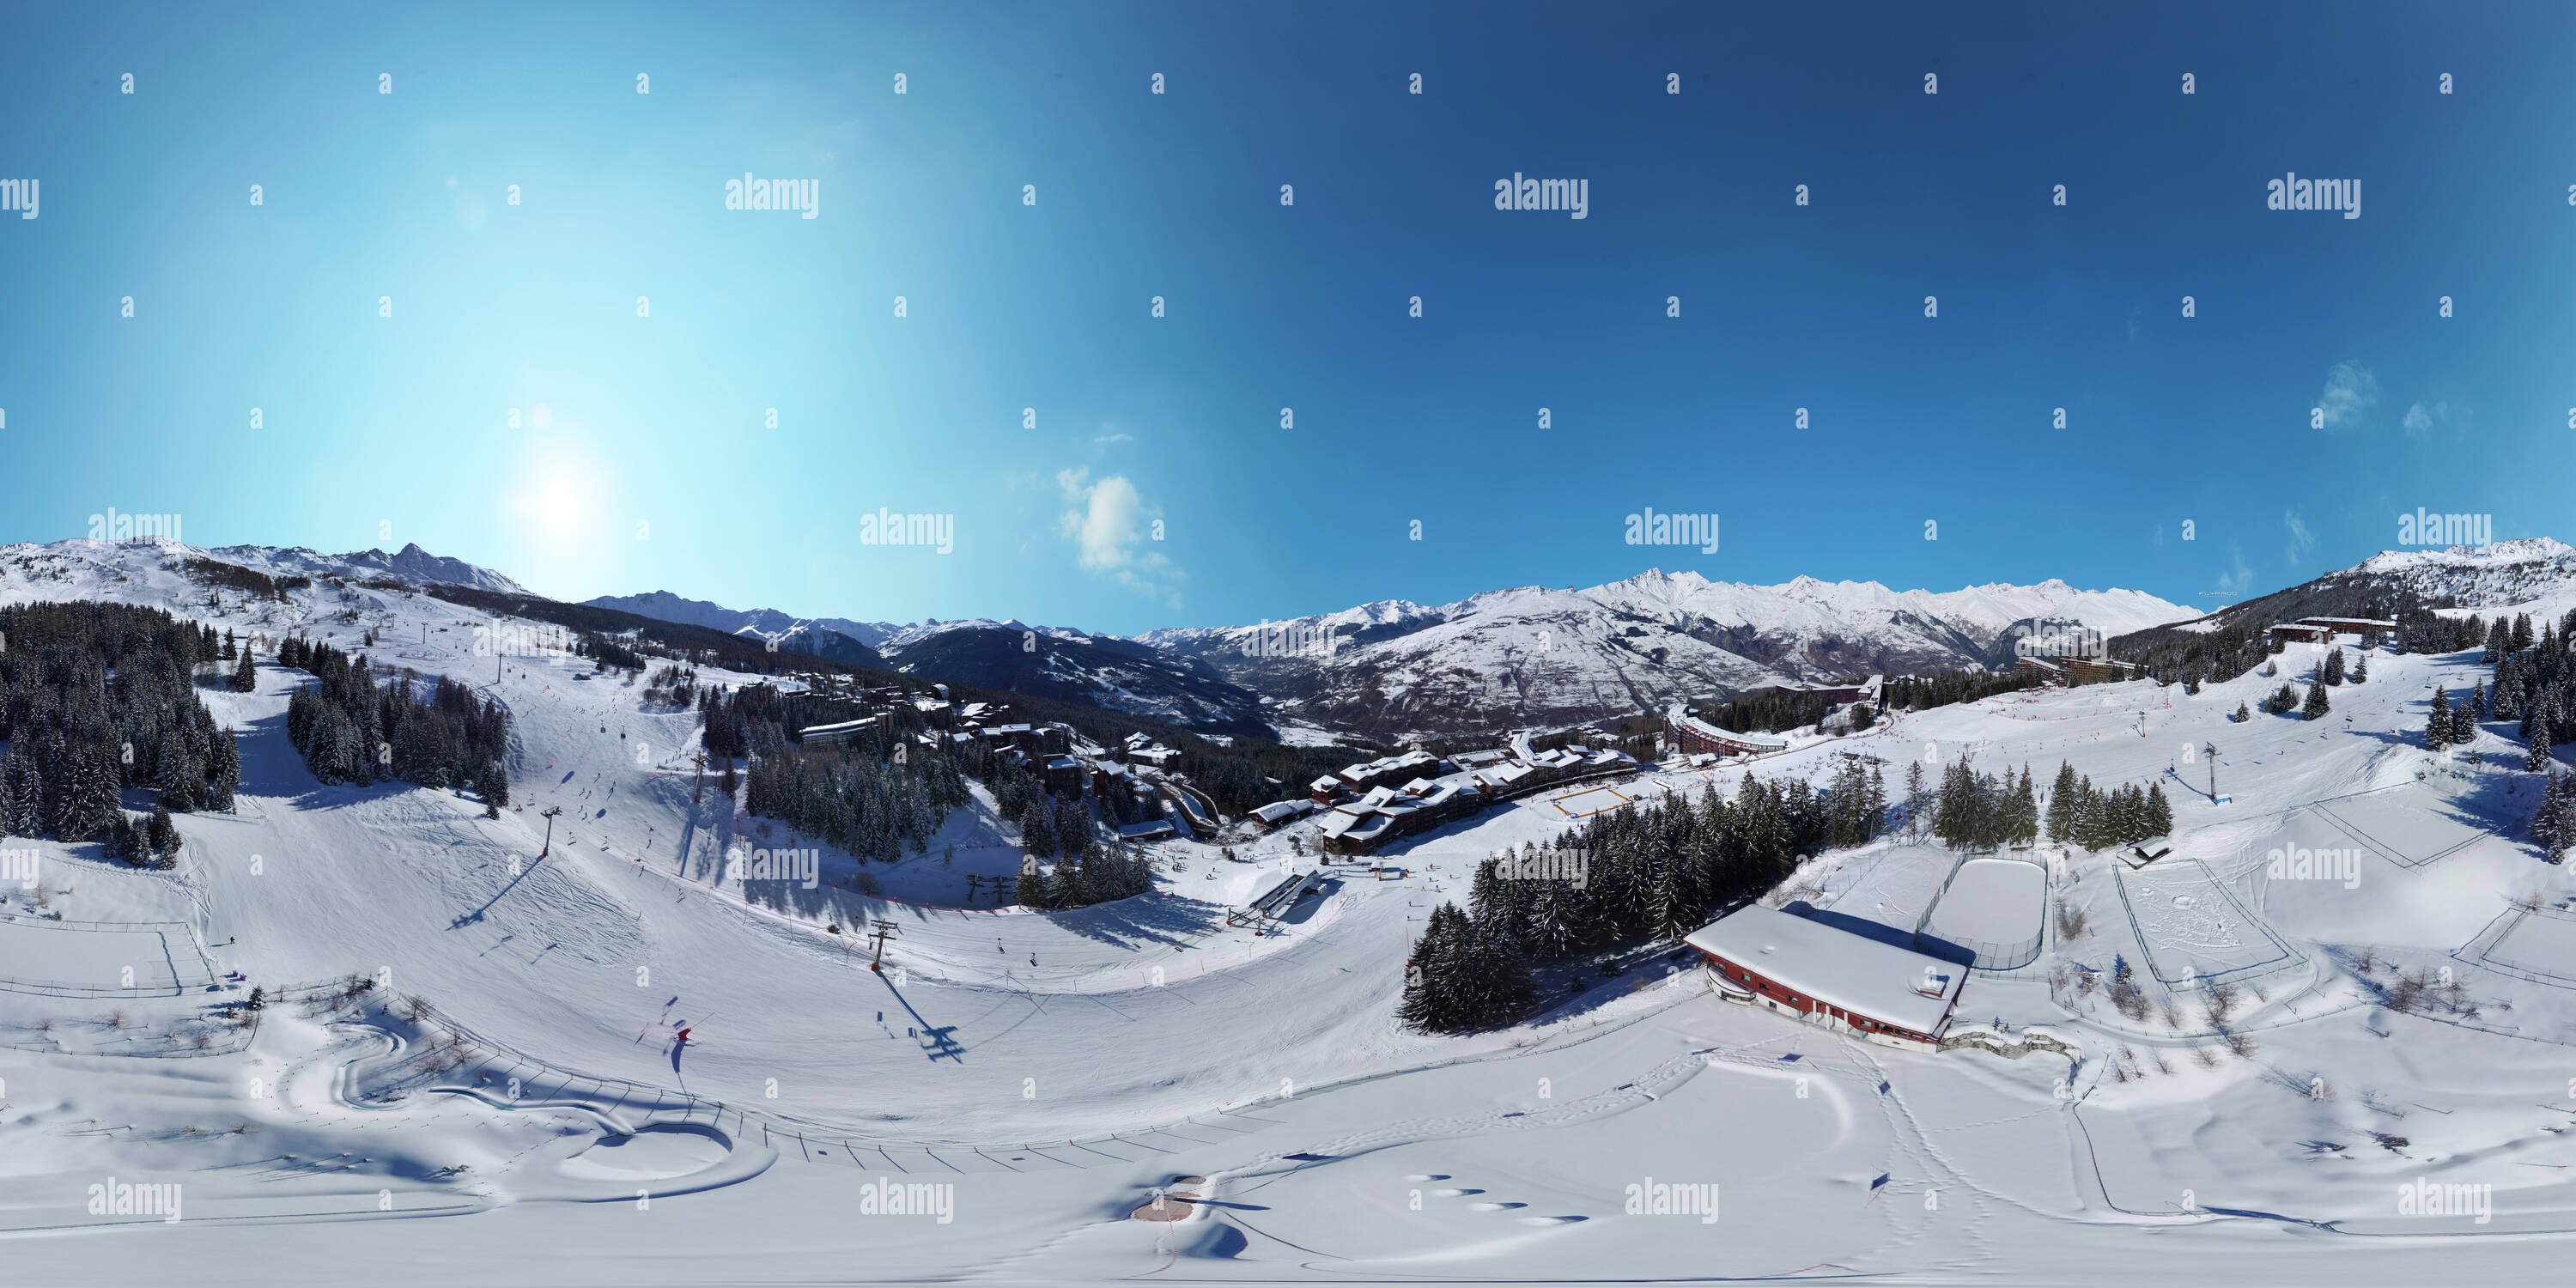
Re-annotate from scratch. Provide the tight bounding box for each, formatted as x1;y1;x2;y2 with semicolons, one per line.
1682;904;1968;1051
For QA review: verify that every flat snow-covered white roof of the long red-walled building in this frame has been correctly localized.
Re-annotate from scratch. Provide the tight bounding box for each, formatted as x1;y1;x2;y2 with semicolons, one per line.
1682;904;1968;1033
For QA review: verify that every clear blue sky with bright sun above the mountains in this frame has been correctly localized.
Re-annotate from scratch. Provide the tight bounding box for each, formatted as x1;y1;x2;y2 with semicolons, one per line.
0;5;2576;634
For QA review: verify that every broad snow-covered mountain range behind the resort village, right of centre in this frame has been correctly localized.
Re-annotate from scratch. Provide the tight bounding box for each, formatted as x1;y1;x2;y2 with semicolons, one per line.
1136;569;2197;734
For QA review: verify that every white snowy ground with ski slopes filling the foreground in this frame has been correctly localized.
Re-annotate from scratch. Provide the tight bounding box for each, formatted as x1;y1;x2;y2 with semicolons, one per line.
0;544;2576;1285
